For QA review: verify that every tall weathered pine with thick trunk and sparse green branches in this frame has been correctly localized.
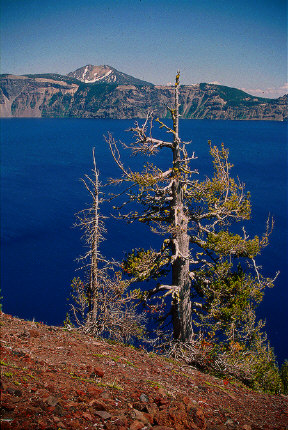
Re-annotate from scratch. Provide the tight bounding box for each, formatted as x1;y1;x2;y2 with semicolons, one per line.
106;72;273;342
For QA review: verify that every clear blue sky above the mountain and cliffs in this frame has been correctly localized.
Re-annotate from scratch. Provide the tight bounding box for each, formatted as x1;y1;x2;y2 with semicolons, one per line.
0;0;288;97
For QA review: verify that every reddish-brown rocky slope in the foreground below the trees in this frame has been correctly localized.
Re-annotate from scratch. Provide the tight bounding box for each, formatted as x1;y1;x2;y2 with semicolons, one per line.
0;313;288;430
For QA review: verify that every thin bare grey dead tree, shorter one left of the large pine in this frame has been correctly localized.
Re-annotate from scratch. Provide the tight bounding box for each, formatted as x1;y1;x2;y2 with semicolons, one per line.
71;150;144;341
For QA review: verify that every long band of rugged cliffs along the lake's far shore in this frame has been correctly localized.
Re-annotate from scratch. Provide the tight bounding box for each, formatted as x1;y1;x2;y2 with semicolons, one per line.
0;75;287;121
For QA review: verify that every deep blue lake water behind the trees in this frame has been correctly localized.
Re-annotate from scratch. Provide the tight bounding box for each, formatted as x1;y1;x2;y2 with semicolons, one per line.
1;119;288;362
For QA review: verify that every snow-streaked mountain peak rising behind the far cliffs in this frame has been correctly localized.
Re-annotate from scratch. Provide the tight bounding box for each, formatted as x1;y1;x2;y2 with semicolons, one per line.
67;64;153;85
